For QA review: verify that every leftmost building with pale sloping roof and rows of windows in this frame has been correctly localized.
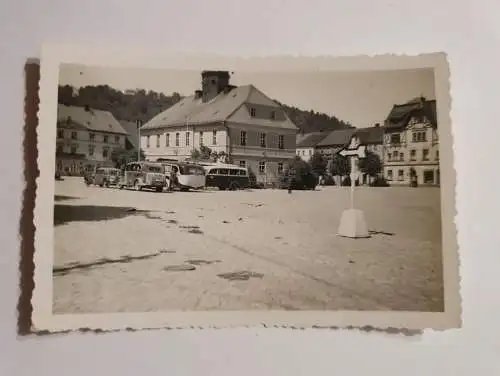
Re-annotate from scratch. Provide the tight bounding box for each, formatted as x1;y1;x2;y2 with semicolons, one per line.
56;104;127;175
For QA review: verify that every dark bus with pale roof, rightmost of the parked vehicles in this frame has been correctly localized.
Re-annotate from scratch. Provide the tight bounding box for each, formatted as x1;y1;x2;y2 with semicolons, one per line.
203;163;250;191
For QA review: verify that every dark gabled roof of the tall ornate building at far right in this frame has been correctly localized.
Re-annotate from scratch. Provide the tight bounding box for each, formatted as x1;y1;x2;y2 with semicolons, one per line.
385;97;437;129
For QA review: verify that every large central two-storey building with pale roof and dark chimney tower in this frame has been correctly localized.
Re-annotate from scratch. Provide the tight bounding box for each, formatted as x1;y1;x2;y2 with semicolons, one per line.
140;71;297;183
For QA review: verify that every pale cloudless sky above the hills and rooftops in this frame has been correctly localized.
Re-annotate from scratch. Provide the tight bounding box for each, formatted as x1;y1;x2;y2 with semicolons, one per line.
59;64;435;128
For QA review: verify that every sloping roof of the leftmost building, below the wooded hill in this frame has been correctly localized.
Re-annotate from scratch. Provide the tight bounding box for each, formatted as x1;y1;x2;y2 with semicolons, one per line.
57;104;127;135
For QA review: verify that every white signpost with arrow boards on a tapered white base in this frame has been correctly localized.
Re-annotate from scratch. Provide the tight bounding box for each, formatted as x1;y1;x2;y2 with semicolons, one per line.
337;137;370;239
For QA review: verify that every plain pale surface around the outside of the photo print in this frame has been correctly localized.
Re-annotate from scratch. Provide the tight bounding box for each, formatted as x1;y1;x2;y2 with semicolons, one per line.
0;0;500;376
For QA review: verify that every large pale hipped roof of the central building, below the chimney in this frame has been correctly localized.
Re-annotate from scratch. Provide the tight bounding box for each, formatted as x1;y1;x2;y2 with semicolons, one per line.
141;85;297;130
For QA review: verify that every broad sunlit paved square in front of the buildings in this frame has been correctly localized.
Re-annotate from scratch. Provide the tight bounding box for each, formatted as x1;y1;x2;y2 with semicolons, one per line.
53;178;443;313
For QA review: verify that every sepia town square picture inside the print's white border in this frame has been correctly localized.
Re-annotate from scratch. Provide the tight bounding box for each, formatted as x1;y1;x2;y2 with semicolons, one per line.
32;49;459;328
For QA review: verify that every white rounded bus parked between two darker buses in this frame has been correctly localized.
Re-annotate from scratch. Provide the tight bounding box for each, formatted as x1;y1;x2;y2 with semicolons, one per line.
157;159;205;191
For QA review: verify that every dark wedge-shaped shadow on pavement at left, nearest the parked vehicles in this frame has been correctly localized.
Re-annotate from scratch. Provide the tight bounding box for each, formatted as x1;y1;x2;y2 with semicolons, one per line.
54;204;147;226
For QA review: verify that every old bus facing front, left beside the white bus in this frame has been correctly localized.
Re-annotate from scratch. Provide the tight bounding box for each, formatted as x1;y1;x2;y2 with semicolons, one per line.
118;162;165;192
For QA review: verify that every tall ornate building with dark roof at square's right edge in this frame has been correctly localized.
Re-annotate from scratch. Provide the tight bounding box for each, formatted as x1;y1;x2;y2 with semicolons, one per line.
384;98;440;185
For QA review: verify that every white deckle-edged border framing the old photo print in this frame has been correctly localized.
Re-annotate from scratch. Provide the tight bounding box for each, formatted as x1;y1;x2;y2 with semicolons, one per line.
32;45;461;332
